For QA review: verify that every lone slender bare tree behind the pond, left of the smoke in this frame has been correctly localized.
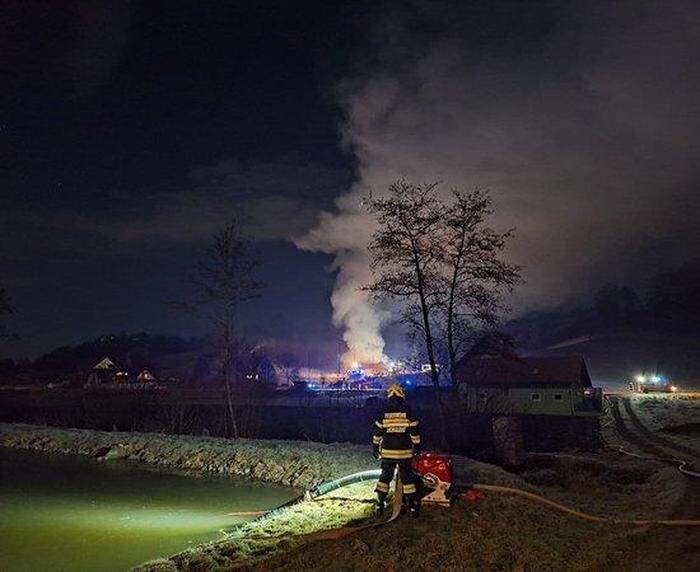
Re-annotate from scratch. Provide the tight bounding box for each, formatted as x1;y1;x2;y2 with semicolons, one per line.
174;221;264;437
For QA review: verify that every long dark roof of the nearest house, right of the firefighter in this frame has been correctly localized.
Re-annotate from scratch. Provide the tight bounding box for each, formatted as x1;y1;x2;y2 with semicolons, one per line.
456;356;591;387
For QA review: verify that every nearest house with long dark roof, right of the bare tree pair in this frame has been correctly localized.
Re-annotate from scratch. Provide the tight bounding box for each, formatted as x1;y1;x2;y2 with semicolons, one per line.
455;354;603;417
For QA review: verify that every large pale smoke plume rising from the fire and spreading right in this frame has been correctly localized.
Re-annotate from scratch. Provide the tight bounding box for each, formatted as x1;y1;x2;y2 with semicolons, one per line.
297;2;700;361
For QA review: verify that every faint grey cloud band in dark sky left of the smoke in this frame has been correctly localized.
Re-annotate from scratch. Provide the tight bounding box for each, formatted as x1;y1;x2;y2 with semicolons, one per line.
0;161;350;255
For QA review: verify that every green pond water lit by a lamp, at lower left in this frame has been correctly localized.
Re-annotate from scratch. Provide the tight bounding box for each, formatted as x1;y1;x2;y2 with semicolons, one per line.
0;449;294;572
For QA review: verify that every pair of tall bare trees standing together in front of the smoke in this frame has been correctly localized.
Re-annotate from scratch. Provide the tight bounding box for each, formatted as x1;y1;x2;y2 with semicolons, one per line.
364;180;519;445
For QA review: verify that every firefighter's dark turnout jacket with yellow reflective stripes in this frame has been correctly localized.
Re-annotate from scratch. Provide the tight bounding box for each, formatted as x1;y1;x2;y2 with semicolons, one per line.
372;397;420;460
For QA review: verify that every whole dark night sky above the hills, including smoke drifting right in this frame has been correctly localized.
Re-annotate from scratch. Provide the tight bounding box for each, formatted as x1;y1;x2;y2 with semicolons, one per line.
0;1;700;356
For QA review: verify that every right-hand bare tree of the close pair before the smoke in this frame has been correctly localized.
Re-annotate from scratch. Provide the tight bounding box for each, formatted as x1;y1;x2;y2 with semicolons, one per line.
442;189;520;385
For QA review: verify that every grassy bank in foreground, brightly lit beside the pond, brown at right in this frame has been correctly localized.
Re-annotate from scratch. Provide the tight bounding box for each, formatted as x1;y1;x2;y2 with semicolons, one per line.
142;455;684;572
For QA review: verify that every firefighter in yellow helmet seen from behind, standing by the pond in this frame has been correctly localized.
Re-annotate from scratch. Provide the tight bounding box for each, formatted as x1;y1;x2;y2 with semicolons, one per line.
372;383;420;517
